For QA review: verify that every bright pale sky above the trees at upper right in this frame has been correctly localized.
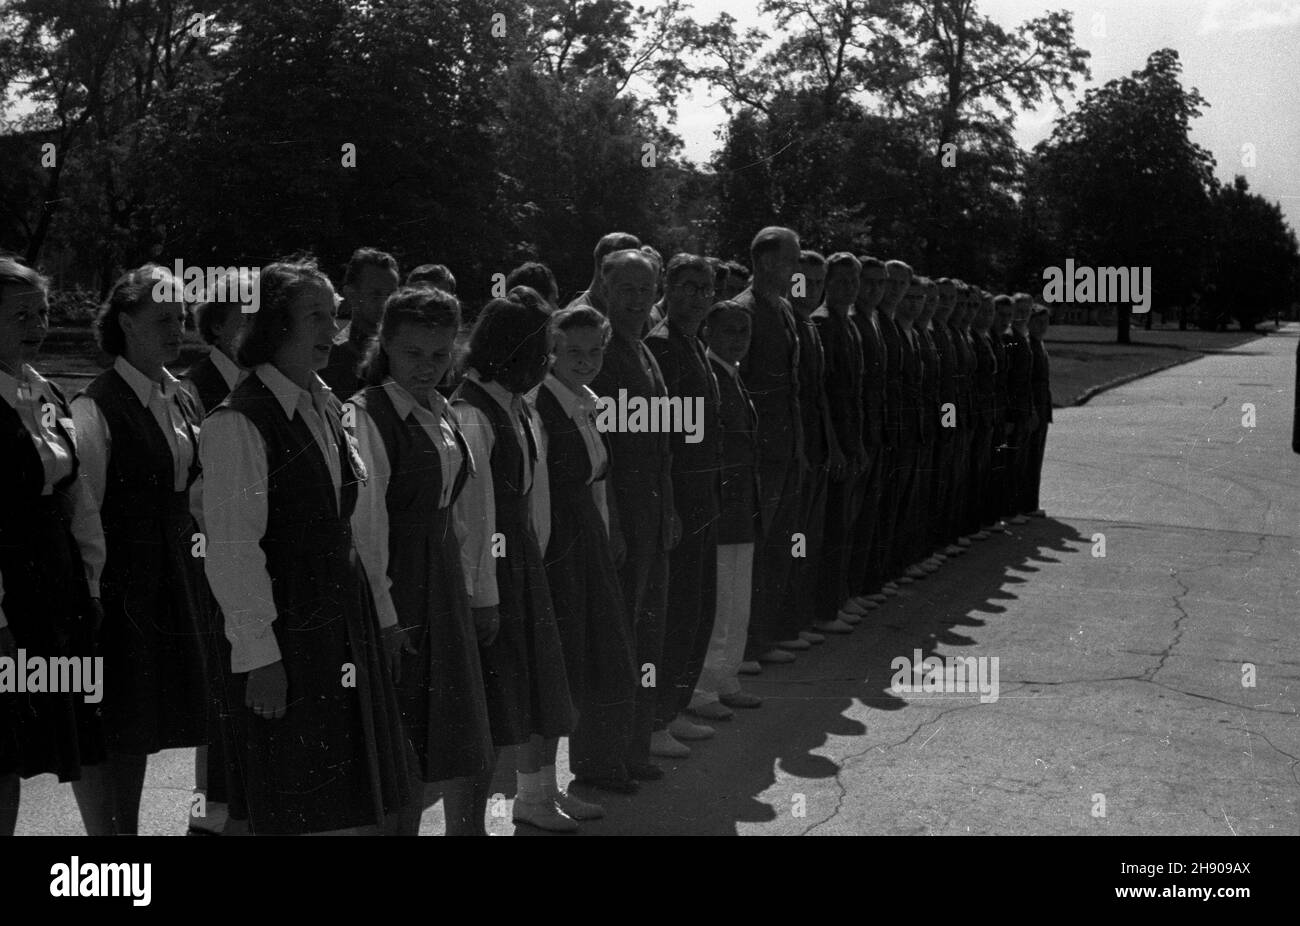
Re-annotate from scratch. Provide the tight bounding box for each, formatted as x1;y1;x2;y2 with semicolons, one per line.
677;0;1300;230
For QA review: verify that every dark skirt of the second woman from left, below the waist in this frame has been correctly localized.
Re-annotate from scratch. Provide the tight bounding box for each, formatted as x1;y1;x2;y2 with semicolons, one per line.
100;492;211;756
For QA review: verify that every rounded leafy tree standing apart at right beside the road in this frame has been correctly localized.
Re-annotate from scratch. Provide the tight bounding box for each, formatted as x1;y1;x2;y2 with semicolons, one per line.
1027;48;1214;343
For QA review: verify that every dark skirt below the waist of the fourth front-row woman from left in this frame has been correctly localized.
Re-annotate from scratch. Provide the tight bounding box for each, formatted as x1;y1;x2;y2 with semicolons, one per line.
389;509;493;782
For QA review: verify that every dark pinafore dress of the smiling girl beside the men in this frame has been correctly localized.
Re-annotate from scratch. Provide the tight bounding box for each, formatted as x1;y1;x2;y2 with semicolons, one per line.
537;380;637;779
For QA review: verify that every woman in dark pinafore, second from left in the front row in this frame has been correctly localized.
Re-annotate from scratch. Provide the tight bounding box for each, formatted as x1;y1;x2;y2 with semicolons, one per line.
73;264;209;835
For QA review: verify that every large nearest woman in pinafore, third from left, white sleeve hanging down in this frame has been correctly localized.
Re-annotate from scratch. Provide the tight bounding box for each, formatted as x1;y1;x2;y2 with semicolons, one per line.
202;263;412;834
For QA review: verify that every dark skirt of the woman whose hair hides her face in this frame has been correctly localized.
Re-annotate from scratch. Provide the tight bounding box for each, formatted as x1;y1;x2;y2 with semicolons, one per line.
481;520;573;749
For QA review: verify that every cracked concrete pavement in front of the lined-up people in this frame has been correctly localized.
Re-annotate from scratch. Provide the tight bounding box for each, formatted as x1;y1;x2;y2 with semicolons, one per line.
18;325;1300;835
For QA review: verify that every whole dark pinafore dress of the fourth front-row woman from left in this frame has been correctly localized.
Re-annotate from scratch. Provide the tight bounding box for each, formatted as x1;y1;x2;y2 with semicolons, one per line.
352;386;493;782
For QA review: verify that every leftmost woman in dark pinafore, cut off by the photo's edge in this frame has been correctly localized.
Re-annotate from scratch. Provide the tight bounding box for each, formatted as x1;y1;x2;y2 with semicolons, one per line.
0;259;104;836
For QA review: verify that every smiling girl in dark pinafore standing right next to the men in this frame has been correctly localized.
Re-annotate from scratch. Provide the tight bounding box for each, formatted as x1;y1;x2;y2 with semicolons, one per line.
536;306;638;795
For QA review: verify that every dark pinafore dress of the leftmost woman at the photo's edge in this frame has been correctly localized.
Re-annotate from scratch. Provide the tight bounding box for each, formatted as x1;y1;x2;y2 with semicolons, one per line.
0;384;104;782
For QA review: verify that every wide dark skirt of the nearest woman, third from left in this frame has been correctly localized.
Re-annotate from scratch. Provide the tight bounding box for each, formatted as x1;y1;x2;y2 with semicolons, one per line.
229;555;411;835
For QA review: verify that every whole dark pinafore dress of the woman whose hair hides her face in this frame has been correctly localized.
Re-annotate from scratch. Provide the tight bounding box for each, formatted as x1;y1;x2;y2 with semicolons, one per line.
456;380;573;748
